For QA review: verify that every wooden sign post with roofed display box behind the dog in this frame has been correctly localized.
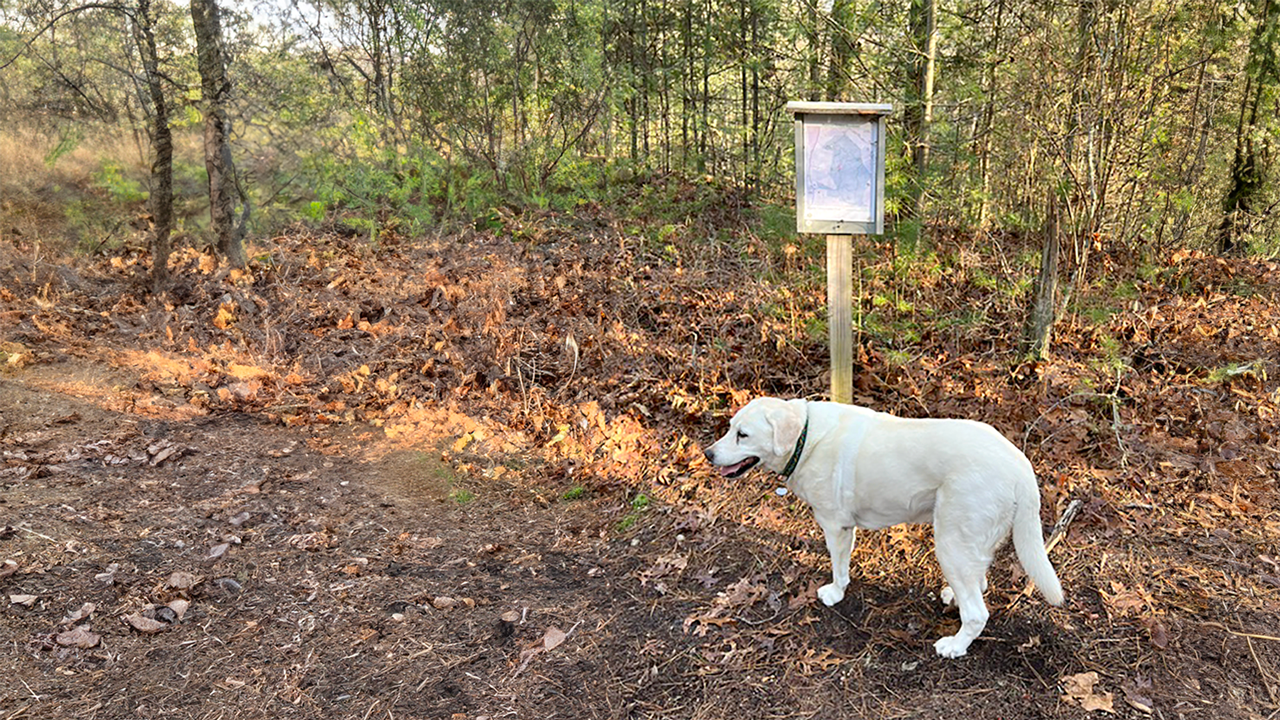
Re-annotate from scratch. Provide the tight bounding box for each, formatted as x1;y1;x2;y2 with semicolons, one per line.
787;102;893;404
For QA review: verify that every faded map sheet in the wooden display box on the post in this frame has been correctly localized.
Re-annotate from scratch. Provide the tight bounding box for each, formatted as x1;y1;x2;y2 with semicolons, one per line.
804;118;879;223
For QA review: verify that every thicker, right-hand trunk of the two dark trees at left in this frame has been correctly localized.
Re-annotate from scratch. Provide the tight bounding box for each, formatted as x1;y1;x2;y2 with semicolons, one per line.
191;0;250;268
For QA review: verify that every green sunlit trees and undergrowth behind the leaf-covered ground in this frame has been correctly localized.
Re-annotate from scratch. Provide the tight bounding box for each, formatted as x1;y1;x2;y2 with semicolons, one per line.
0;0;1280;265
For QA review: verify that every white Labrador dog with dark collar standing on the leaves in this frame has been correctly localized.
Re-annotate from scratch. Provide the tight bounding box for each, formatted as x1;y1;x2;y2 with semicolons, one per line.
707;397;1062;657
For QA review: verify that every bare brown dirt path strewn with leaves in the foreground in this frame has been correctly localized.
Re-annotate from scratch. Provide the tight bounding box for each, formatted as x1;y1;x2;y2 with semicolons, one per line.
0;353;1264;719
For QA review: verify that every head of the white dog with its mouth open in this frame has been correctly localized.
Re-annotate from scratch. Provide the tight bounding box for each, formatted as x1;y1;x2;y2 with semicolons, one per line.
704;397;805;478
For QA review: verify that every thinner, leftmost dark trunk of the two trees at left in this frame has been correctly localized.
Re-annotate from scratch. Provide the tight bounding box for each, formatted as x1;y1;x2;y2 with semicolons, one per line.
133;0;173;293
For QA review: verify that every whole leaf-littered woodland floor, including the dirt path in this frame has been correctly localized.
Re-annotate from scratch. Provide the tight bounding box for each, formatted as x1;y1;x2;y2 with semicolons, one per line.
0;202;1280;720
